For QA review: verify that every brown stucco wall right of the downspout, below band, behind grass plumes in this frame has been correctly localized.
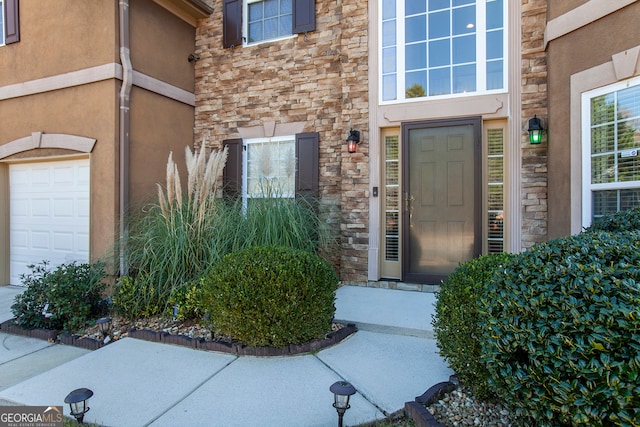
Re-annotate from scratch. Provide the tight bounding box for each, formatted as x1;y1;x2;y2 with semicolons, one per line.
129;88;193;208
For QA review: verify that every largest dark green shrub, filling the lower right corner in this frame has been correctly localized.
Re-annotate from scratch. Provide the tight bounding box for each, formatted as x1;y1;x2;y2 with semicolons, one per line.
481;232;640;426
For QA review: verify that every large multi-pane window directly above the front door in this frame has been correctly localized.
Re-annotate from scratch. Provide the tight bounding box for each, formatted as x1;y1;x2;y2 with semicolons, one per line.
378;0;507;102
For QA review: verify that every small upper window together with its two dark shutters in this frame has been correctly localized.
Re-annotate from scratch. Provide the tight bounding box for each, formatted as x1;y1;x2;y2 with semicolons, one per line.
222;0;316;48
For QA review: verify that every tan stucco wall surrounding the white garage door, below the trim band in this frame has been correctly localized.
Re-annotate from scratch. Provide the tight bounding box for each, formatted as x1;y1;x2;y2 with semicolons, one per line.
0;80;119;278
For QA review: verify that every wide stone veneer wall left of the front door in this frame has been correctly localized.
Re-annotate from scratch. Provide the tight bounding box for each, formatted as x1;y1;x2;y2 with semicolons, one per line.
195;0;369;281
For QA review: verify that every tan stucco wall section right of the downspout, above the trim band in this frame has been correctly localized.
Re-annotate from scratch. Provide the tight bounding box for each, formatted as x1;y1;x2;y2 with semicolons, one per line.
130;0;195;92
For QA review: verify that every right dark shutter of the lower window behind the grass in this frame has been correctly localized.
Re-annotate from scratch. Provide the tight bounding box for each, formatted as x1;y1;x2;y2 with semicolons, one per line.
296;132;320;197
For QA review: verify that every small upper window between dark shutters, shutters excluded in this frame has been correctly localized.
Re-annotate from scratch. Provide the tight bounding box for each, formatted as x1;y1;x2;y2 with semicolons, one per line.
245;0;293;43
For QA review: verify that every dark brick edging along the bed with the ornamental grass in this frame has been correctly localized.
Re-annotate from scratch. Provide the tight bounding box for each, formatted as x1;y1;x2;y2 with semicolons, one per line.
0;319;358;356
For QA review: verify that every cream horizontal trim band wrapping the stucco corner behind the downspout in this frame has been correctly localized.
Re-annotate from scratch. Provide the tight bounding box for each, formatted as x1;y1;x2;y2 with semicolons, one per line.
0;62;196;107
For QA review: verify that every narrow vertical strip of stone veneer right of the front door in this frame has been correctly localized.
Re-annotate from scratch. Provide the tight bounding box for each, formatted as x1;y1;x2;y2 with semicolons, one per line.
521;0;548;249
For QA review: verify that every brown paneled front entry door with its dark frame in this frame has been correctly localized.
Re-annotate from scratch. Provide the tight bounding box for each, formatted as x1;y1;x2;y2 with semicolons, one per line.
402;118;481;283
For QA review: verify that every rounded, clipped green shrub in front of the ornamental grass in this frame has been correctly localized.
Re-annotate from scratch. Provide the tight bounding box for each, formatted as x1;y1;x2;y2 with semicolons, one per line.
203;246;338;347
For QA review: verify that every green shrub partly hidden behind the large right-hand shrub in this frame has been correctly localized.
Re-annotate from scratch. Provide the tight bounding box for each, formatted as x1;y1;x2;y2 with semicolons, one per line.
433;253;511;398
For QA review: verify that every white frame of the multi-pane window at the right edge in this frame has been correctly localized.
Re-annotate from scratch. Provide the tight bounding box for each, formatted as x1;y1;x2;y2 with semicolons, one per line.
581;77;640;228
